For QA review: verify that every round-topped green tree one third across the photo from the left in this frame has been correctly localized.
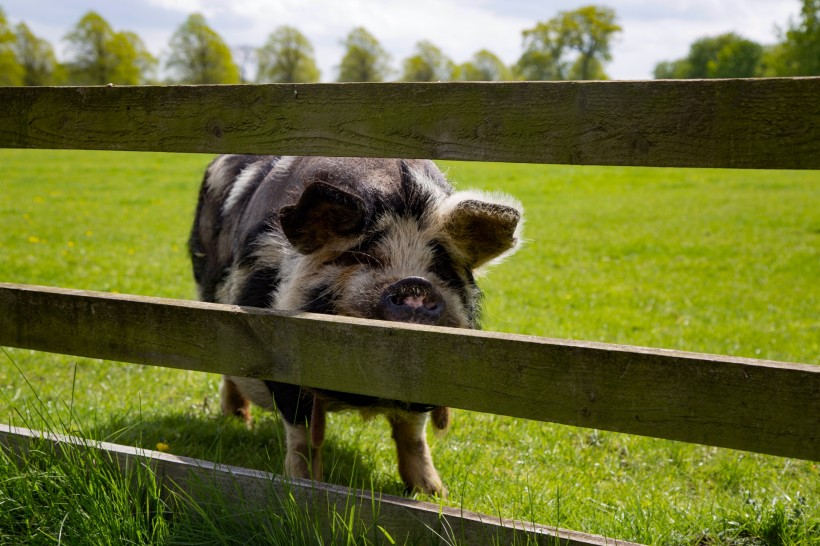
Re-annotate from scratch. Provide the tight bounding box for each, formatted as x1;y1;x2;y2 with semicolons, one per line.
256;26;320;83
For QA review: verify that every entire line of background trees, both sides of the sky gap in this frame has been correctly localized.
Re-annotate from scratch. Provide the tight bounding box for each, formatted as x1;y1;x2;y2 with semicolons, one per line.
0;0;820;85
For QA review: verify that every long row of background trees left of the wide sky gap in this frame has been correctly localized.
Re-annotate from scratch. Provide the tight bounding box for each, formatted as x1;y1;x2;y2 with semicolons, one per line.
0;6;621;85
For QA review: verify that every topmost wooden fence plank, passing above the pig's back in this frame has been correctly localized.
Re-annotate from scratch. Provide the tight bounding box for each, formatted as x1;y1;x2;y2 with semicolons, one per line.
0;78;820;169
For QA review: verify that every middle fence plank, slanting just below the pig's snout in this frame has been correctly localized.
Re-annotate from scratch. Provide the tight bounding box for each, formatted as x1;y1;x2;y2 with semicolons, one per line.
0;284;820;460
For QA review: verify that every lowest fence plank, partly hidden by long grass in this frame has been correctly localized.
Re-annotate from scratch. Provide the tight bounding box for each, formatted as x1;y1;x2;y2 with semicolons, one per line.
0;424;638;546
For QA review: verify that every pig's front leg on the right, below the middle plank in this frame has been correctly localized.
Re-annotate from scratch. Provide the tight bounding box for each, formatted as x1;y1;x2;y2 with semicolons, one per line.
390;413;447;497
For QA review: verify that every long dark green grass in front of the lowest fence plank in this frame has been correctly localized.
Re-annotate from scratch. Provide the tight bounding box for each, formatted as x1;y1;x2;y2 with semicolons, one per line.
0;355;392;546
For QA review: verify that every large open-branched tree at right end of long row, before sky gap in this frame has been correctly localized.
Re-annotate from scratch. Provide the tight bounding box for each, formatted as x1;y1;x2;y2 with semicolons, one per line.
515;6;621;80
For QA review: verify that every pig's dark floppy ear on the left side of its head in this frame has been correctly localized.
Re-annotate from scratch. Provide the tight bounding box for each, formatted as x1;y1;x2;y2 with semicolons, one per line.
279;182;366;254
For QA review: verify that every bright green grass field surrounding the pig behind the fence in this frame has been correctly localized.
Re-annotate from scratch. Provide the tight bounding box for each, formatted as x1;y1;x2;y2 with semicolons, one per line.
0;150;820;546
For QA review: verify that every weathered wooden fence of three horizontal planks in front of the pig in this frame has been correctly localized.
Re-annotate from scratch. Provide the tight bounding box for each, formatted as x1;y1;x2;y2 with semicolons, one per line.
0;78;820;544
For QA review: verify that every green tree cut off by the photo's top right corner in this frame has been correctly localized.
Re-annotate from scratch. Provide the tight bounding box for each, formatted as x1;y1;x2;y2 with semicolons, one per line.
765;0;820;76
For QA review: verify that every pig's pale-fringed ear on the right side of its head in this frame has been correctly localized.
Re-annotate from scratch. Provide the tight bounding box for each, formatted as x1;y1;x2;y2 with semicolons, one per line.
445;194;522;268
